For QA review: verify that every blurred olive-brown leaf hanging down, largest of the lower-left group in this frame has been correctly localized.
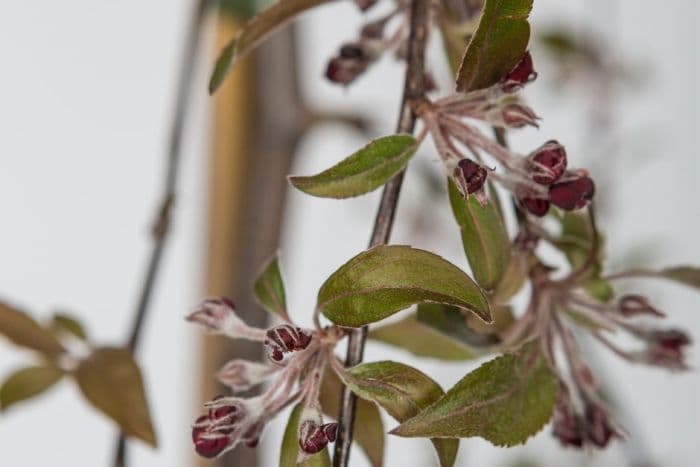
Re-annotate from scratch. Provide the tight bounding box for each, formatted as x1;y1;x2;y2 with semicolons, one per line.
75;347;156;447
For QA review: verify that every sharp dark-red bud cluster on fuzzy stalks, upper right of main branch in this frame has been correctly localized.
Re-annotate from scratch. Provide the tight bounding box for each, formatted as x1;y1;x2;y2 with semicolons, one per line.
415;52;595;217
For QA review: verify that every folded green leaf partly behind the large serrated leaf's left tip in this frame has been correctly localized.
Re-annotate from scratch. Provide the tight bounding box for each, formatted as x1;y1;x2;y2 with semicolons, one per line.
344;361;459;467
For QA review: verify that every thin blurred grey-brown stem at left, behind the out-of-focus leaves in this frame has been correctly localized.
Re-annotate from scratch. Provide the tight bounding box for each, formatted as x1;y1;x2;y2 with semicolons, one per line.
114;0;211;467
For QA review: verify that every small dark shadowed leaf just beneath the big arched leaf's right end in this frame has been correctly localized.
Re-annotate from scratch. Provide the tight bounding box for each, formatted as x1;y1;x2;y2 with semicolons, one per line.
416;303;501;354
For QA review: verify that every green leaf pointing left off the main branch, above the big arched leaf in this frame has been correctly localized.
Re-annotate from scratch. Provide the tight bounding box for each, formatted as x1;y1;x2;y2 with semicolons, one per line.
289;135;418;198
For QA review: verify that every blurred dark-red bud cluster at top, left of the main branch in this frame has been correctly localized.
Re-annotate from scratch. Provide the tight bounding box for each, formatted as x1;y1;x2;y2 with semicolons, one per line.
326;8;408;85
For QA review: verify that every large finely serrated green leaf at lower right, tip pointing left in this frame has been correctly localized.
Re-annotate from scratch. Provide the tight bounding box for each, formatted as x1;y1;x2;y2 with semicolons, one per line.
391;344;557;446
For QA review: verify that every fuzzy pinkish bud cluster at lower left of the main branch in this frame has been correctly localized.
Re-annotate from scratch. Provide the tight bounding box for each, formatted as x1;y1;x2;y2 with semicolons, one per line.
187;298;340;458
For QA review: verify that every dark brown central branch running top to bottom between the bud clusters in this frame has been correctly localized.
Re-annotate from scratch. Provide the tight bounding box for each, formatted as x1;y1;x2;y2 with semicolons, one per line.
333;0;428;467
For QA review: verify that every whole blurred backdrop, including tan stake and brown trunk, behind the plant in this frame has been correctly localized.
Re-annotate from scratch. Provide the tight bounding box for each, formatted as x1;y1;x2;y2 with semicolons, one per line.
0;0;700;467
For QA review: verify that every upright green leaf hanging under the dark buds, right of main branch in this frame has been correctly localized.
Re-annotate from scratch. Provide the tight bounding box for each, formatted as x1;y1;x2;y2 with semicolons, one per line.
448;180;510;290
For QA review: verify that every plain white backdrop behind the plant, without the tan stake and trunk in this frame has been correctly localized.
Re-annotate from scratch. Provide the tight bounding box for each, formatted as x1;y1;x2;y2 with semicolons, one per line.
0;0;700;467
